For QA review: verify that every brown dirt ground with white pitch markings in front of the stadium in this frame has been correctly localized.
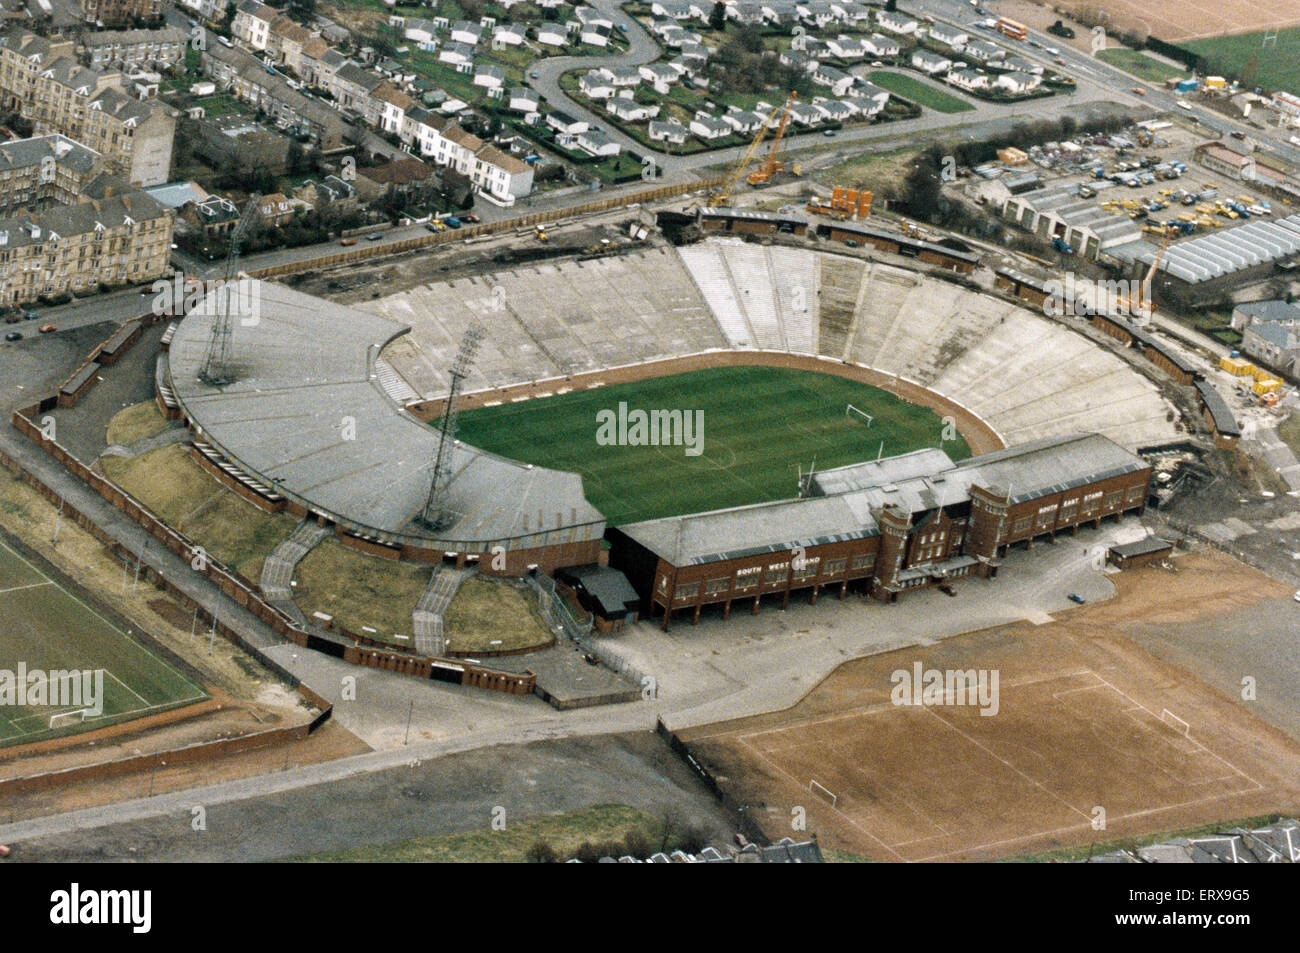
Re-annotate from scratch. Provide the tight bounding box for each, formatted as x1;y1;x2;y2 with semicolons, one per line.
683;553;1300;861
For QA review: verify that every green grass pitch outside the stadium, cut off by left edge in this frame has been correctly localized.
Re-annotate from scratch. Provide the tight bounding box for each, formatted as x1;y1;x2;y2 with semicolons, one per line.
0;541;208;746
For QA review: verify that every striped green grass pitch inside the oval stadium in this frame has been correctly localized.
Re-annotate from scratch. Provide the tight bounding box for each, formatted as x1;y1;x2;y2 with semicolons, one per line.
456;367;970;525
